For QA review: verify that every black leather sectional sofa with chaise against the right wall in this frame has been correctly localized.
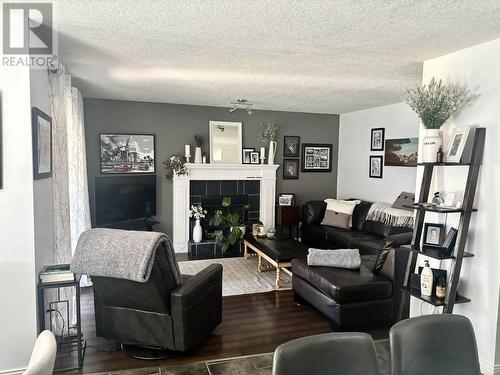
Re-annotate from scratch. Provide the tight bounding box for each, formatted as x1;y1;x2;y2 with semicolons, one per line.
292;201;412;330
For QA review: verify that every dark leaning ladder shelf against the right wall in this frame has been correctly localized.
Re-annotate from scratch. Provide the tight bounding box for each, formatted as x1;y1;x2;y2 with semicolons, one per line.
399;128;486;319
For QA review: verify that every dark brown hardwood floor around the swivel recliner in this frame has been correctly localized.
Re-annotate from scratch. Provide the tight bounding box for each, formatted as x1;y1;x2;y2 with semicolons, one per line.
60;290;388;373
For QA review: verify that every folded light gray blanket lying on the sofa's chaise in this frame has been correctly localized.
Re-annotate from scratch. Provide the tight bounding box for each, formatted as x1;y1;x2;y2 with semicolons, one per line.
307;248;361;269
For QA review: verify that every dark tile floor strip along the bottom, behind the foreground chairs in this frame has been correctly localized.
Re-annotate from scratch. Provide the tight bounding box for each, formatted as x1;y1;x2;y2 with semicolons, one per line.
86;340;390;375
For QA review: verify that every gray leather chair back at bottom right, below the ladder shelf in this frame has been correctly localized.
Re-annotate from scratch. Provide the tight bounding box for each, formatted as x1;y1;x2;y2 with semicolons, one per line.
389;314;480;375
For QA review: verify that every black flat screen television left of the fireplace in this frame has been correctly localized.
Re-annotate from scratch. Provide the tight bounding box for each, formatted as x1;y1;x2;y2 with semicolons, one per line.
94;175;156;227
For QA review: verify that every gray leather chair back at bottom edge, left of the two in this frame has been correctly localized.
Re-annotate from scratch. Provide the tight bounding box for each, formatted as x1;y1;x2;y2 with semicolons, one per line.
273;332;378;375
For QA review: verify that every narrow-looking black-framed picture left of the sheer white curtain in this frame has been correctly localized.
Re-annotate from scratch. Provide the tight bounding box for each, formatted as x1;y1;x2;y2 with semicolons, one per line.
31;107;52;180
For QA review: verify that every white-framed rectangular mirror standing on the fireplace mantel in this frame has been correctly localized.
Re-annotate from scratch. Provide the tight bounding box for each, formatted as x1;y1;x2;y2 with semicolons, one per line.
209;121;242;164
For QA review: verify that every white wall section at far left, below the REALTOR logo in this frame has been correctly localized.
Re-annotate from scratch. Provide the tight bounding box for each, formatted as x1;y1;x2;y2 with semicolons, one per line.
0;67;36;373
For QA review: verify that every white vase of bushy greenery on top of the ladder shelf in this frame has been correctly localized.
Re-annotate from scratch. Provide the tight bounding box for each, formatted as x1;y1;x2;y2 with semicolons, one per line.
403;77;476;163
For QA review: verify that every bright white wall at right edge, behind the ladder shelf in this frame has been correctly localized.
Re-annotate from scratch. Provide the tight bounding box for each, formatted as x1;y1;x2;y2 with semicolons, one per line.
418;39;500;374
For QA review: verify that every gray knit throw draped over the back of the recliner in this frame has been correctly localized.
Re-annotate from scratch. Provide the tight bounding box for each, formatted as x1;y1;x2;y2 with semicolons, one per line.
70;228;181;284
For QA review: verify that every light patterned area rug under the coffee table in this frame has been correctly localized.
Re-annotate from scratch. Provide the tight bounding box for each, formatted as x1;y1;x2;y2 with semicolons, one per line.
179;257;291;296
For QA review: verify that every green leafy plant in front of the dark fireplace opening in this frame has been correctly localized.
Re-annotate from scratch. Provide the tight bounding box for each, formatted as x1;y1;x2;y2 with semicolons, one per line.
210;197;248;252
